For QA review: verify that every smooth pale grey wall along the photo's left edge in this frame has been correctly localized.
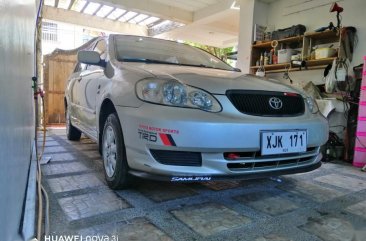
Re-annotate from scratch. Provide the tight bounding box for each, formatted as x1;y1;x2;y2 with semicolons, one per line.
0;0;36;241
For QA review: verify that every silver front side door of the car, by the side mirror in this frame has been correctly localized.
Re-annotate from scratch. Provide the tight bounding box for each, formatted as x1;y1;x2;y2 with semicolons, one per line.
79;39;107;138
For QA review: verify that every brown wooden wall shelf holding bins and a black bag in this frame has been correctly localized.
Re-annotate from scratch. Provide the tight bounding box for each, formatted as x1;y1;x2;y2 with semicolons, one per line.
250;30;352;74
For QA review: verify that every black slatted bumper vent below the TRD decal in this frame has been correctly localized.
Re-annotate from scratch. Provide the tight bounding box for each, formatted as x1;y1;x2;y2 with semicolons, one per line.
150;150;202;166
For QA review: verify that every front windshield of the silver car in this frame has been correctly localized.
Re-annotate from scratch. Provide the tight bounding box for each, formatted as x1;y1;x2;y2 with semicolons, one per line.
115;36;234;71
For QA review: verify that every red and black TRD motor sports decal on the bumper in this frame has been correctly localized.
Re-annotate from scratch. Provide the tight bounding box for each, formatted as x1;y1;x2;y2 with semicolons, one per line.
137;124;179;146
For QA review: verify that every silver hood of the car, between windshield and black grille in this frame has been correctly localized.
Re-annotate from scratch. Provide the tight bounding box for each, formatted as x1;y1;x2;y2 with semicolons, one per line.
129;63;298;94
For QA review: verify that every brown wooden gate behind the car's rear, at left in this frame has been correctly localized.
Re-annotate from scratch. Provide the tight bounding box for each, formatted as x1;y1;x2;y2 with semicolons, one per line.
43;38;96;125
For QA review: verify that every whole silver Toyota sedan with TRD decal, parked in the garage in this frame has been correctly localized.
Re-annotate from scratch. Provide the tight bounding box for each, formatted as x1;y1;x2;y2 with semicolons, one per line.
65;35;328;189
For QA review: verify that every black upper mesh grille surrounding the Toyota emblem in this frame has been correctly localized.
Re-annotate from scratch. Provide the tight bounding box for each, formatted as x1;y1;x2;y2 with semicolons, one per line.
226;90;305;117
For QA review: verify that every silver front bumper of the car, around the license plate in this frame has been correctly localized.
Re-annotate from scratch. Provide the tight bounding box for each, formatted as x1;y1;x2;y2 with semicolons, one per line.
116;100;328;181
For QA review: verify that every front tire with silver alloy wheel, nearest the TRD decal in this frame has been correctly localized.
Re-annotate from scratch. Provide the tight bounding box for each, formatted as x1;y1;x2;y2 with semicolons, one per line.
102;113;131;189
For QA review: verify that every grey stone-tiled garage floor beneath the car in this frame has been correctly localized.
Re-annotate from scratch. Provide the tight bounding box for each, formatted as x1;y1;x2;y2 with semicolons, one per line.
39;129;366;241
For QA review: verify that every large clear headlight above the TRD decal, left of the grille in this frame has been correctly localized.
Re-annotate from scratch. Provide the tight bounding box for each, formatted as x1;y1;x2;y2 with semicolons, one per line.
136;79;221;112
